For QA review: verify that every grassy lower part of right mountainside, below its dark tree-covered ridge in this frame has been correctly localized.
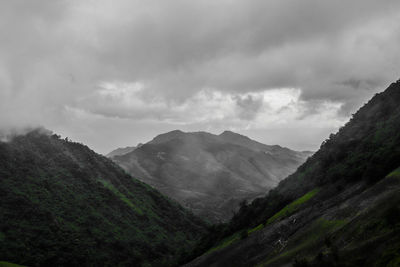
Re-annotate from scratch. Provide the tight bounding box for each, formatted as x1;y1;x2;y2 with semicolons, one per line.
186;166;400;267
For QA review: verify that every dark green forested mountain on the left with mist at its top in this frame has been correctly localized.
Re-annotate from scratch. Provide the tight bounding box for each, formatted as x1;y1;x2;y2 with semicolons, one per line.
0;129;206;266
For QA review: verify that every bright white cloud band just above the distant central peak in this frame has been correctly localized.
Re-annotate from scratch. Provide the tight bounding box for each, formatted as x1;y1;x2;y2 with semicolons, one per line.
75;82;343;129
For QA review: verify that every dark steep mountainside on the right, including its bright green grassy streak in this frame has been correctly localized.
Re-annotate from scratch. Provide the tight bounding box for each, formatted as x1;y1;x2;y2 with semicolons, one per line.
185;78;400;267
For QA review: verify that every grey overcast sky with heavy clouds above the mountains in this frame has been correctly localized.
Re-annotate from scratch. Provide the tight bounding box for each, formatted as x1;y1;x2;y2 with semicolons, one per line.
0;0;400;153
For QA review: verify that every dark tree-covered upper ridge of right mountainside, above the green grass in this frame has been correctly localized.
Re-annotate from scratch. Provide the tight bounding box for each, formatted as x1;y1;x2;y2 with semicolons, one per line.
230;81;400;234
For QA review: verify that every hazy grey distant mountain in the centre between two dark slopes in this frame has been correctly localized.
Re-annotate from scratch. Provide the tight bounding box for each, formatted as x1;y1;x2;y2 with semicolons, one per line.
112;130;311;222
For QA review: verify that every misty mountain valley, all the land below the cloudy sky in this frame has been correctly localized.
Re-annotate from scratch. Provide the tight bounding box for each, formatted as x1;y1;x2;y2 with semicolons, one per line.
0;82;400;266
